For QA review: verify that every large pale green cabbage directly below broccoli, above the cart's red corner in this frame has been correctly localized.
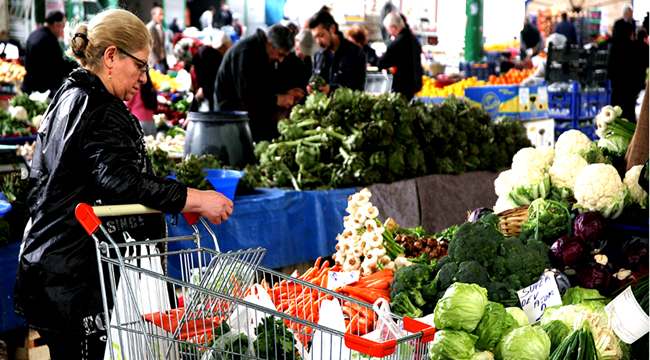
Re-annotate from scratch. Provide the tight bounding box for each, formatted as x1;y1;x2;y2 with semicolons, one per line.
433;283;488;332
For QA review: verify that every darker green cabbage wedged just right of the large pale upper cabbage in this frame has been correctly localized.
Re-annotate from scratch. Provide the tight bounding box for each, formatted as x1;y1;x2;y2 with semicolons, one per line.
474;301;518;351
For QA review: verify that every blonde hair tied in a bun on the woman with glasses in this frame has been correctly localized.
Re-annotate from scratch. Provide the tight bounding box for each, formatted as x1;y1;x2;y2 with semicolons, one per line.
67;9;152;72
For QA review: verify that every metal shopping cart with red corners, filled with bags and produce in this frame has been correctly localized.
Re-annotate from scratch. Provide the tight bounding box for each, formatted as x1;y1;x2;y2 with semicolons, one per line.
76;204;435;360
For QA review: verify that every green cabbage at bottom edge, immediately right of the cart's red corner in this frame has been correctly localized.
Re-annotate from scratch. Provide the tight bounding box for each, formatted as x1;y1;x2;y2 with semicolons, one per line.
429;330;477;360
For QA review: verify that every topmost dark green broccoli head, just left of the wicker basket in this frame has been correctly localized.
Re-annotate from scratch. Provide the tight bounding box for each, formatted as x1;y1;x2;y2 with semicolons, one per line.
448;221;502;270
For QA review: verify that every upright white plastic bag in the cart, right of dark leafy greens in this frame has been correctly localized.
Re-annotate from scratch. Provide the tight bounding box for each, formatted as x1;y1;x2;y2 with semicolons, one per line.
310;299;350;360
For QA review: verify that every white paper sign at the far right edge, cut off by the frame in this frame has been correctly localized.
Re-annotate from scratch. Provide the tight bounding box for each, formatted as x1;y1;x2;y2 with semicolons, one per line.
605;286;650;344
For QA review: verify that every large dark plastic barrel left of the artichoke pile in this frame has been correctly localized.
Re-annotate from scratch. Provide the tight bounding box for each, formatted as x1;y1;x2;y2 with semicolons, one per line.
185;111;255;168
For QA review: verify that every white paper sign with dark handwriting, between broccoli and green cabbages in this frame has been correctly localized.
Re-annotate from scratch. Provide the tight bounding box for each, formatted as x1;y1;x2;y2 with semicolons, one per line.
517;275;562;325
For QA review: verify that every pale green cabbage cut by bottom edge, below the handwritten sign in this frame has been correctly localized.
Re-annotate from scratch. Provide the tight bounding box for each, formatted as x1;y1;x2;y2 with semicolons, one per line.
495;325;551;360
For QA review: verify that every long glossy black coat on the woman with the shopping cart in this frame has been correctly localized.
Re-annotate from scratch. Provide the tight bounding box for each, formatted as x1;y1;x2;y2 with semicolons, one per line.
14;69;187;334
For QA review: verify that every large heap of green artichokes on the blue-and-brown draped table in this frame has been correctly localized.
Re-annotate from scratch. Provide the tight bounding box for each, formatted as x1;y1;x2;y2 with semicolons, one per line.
255;88;530;190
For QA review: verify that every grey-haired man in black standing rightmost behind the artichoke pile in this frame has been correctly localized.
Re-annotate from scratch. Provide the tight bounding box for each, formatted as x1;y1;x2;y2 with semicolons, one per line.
379;12;422;100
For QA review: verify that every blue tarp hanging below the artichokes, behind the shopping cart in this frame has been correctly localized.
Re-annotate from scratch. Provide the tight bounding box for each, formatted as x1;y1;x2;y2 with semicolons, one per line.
167;188;356;278
